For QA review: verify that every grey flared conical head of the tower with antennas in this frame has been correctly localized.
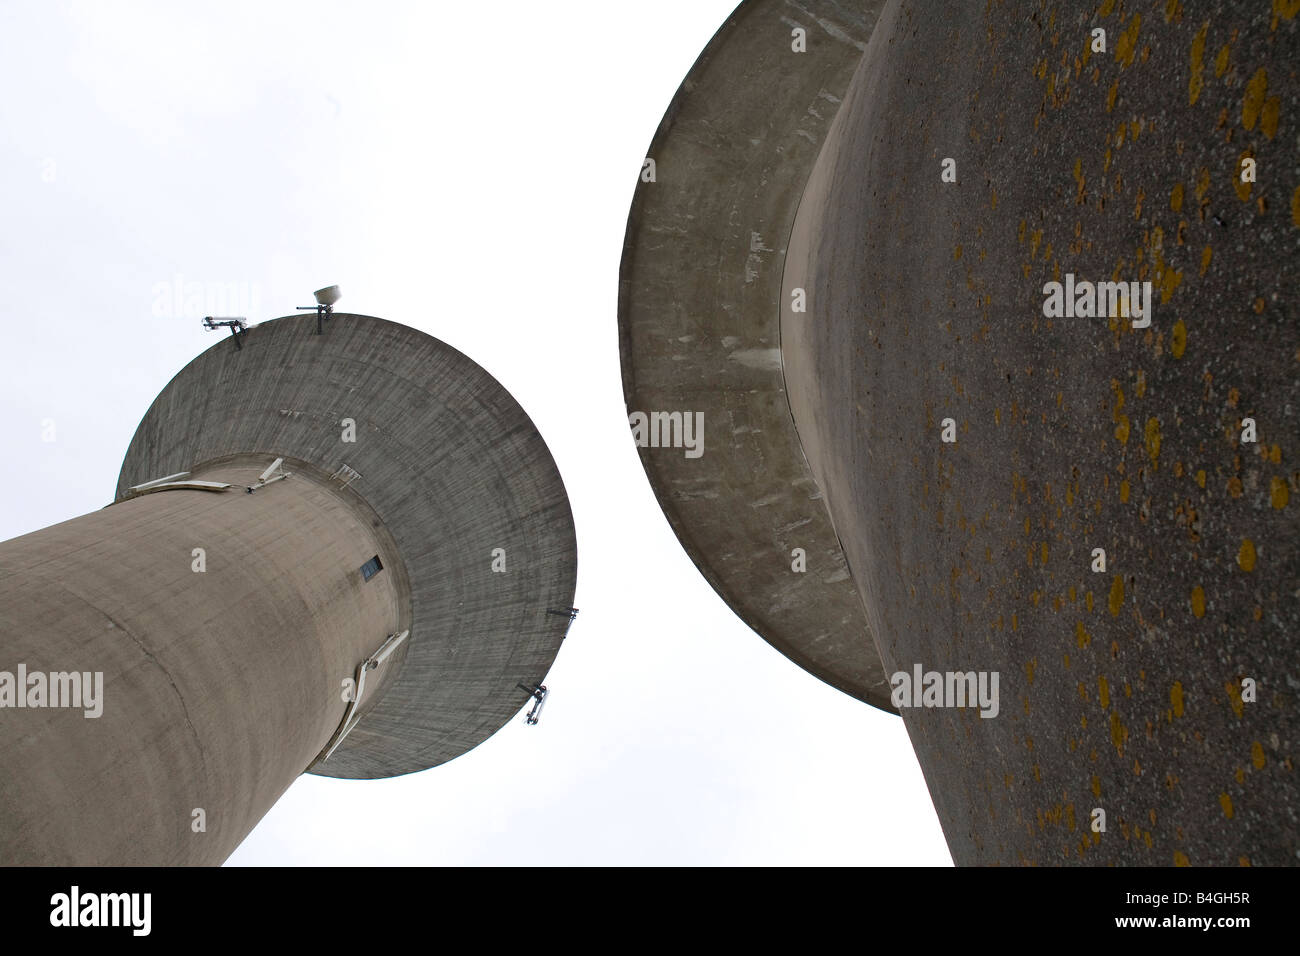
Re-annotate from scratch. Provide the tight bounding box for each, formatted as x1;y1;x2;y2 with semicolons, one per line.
117;313;577;779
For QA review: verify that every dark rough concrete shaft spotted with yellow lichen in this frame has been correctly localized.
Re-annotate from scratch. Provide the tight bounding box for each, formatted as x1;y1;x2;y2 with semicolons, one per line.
783;0;1300;865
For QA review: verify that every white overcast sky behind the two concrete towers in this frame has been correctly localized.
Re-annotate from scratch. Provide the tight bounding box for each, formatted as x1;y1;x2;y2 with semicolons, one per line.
0;0;950;865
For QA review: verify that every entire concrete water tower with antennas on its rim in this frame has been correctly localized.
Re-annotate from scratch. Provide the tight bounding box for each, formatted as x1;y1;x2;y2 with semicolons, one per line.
0;315;576;865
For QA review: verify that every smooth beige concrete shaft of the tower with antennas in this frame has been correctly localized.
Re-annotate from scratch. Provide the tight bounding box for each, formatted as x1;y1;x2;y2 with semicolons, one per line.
0;457;411;865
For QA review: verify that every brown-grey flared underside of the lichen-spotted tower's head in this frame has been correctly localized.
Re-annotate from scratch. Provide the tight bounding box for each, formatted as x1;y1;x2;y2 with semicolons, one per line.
619;0;893;710
